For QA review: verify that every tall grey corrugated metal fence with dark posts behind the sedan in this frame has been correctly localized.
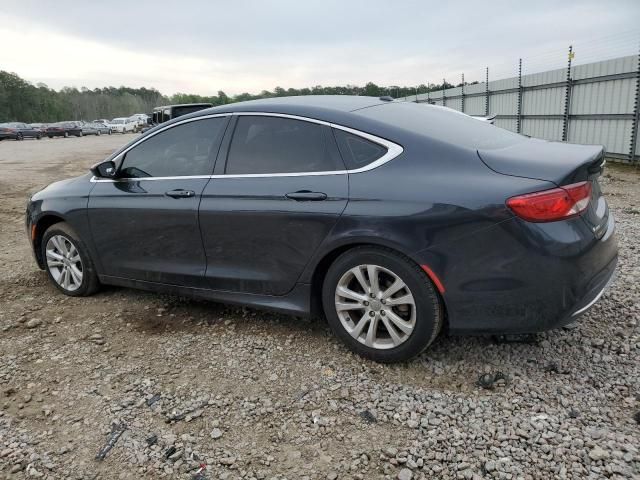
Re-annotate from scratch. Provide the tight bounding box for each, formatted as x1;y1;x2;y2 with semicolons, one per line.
399;54;640;161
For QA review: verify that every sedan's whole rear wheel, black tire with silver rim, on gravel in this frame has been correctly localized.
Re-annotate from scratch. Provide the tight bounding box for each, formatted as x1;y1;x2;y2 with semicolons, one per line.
322;247;444;363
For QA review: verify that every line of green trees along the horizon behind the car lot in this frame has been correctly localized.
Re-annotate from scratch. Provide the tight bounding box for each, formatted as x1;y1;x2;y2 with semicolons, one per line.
0;70;477;123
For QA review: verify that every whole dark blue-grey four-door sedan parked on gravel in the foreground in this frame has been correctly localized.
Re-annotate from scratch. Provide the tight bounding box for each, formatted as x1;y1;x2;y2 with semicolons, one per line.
26;96;618;362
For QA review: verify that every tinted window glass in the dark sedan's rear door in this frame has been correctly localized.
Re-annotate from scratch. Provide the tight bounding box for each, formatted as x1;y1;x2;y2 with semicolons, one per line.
225;115;344;175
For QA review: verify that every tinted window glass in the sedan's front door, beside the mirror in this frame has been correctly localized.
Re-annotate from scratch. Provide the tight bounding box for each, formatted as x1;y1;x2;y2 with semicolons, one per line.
119;117;227;178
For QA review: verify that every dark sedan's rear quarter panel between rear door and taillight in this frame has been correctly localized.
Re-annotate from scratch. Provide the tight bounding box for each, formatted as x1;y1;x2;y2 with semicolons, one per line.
301;137;553;282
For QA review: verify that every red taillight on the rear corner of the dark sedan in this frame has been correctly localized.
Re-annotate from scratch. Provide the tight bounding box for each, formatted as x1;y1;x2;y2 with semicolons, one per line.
507;182;591;222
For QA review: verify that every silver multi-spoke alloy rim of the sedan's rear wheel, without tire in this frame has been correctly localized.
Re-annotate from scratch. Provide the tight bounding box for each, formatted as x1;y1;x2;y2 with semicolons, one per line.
335;265;416;349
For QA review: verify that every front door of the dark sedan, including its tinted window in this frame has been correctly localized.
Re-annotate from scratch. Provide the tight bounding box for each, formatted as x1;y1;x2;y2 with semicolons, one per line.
88;116;229;287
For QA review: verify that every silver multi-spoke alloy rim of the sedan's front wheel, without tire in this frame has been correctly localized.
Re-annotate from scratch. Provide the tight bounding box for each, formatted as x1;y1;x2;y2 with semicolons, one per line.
45;235;83;292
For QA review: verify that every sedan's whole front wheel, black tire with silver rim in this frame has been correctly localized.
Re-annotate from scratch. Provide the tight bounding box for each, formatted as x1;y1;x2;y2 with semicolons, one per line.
40;222;100;297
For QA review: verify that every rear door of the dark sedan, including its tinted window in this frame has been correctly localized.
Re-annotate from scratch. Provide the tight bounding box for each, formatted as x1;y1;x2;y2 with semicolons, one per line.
200;114;349;295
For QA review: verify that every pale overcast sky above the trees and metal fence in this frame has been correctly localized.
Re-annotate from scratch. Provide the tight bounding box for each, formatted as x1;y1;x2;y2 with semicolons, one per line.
0;0;640;95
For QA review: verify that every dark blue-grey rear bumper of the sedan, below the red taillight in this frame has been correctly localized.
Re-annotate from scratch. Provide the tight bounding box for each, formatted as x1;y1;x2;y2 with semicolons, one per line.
420;212;618;334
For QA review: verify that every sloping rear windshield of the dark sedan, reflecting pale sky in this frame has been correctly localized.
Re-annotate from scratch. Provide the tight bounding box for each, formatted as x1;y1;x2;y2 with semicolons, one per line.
353;102;527;150
